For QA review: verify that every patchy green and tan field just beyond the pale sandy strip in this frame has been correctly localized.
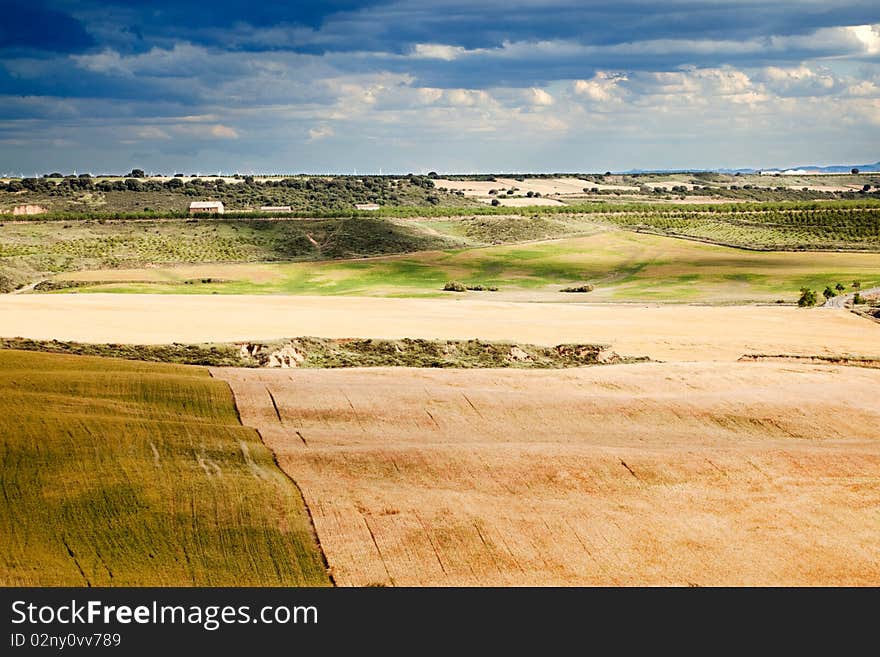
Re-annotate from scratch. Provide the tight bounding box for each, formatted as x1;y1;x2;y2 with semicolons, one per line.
55;230;880;303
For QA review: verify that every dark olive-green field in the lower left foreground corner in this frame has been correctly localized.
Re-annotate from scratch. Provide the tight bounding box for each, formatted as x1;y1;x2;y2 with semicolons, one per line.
0;351;329;586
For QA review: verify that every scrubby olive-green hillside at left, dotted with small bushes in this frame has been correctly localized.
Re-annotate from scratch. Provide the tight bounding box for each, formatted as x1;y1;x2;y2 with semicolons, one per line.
0;218;456;290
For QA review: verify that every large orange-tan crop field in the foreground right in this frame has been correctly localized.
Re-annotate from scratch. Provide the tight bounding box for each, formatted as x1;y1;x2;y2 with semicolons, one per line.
214;363;880;586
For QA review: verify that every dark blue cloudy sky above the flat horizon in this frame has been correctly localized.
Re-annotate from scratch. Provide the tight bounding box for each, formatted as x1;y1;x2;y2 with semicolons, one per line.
0;0;880;176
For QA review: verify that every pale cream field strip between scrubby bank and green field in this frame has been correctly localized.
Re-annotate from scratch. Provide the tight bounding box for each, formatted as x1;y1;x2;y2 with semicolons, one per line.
0;294;880;361
